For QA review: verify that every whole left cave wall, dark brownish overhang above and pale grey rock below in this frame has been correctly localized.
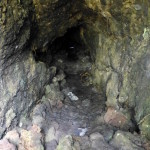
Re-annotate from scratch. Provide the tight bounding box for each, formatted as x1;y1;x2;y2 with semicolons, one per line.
0;0;84;136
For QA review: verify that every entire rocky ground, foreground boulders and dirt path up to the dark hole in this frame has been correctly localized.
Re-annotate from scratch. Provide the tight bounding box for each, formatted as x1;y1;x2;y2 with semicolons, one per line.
0;45;149;150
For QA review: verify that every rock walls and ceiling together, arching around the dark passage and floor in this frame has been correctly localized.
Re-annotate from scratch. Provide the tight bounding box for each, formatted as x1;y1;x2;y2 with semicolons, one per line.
0;0;150;144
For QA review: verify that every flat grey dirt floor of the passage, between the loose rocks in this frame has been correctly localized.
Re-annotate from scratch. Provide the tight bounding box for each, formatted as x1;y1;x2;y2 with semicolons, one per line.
45;75;108;141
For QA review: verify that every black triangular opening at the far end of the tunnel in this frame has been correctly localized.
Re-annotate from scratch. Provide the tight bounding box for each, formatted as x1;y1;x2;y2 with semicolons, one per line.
34;26;91;74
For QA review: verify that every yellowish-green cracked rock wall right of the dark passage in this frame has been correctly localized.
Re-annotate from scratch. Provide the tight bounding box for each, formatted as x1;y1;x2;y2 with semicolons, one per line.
81;0;150;138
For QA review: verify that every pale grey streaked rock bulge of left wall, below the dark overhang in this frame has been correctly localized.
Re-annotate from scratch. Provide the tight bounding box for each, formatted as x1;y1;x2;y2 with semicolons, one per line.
0;51;50;135
